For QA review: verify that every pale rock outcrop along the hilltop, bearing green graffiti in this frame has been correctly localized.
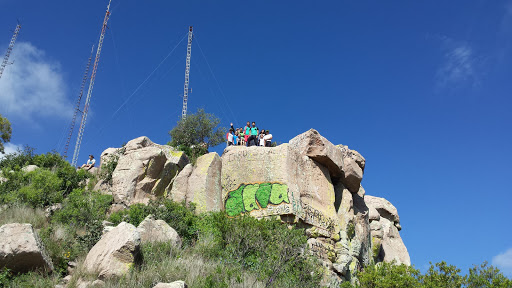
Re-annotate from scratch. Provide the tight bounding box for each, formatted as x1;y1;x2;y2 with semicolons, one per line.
98;129;410;286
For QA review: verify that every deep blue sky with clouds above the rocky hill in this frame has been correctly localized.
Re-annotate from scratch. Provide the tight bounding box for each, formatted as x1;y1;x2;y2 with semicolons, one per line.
0;0;512;277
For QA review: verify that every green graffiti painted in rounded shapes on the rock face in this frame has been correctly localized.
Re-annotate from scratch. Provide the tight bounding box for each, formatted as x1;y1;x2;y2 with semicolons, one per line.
225;183;290;216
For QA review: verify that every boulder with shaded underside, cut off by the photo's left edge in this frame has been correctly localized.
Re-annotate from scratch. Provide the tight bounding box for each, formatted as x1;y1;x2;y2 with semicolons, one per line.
0;223;53;273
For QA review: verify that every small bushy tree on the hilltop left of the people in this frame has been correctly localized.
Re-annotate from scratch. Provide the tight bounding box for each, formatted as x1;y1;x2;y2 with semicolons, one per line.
169;109;226;161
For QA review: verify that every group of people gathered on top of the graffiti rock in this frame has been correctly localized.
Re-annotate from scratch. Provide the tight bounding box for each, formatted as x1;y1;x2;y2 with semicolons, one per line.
226;121;272;147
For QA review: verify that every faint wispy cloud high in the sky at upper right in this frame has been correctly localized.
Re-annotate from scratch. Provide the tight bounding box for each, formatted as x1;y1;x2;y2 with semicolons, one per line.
436;36;480;87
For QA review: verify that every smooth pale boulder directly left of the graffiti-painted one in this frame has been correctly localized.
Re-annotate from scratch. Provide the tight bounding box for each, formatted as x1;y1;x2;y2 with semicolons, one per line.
170;152;223;213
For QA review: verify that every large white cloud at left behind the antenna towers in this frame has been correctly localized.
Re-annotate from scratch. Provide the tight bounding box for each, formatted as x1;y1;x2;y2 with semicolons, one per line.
0;42;72;120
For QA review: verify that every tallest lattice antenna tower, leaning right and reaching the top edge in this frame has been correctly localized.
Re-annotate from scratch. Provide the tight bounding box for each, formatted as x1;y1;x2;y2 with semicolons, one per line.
71;0;112;166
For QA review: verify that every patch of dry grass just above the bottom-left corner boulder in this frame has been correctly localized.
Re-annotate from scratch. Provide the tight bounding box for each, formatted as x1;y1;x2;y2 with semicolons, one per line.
0;204;48;229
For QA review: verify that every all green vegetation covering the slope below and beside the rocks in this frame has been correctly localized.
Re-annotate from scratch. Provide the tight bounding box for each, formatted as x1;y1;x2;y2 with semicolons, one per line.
0;148;512;288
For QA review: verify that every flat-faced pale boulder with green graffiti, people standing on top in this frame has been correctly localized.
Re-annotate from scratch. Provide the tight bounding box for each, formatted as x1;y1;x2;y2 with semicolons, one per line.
222;144;339;238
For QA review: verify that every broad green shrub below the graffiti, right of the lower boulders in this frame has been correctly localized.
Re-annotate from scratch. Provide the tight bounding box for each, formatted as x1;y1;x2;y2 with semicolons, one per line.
198;212;320;287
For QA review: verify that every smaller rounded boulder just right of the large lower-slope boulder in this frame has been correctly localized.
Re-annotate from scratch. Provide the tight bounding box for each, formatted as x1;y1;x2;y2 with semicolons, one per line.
137;215;181;247
